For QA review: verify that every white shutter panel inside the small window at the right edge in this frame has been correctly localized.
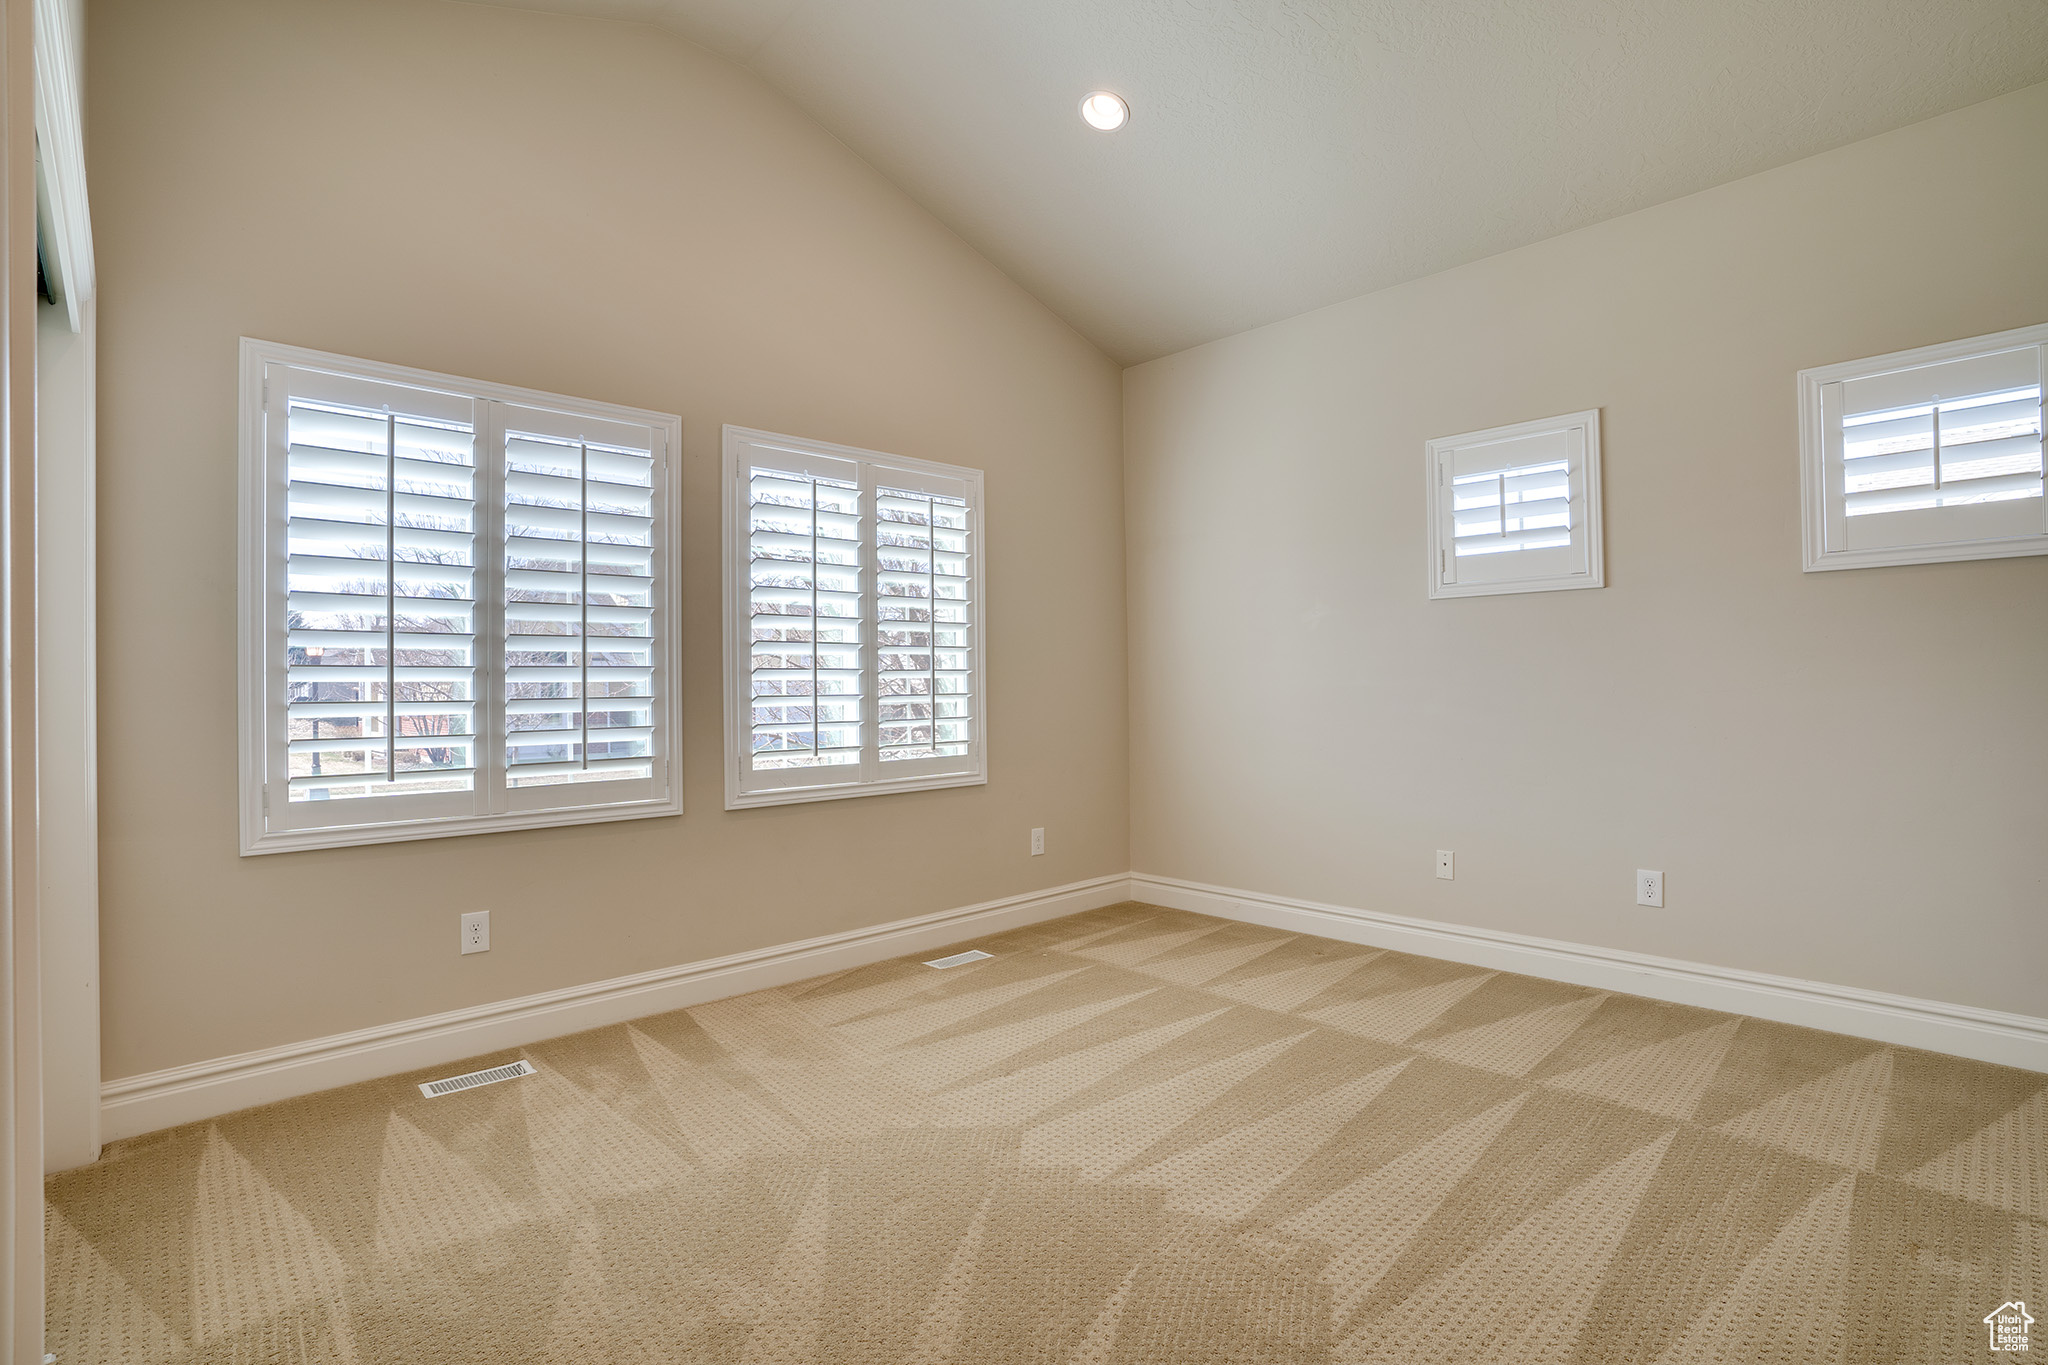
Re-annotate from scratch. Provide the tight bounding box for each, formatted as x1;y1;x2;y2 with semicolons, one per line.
1821;346;2048;551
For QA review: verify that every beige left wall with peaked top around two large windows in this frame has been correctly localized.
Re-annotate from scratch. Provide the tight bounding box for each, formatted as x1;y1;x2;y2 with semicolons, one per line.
88;0;1128;1078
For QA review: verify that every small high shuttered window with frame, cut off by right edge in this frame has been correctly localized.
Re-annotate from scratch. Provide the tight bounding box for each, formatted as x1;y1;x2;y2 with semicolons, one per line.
1798;325;2048;573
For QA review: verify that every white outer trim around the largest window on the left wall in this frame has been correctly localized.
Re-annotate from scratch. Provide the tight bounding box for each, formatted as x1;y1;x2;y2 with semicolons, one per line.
236;338;682;857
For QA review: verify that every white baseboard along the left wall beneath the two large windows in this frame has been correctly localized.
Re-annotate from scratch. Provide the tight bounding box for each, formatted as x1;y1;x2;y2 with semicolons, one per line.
100;874;1130;1142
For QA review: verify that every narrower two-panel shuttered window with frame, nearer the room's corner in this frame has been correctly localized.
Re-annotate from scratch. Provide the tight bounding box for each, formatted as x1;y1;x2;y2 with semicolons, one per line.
725;426;987;808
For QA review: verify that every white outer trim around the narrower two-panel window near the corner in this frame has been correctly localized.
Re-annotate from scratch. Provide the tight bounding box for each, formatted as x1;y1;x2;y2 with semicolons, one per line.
719;426;989;810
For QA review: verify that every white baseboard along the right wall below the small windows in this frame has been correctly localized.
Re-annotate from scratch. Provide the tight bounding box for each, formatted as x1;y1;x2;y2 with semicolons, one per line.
1130;872;2048;1072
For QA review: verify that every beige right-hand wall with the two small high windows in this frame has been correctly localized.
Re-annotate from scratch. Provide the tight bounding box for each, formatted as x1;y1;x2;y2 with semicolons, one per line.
1124;86;2048;1015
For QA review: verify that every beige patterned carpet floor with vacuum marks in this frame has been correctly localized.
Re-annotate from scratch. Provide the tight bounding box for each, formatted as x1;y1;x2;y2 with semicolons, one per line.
49;905;2048;1365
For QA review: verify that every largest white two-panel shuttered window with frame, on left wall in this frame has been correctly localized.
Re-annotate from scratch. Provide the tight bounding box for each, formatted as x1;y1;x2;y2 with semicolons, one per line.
242;340;682;853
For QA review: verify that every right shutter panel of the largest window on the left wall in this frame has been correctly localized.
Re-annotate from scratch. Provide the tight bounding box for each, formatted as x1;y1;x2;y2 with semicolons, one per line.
492;403;670;808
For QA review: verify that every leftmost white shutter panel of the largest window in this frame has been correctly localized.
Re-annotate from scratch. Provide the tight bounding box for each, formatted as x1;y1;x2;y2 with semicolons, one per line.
266;366;479;829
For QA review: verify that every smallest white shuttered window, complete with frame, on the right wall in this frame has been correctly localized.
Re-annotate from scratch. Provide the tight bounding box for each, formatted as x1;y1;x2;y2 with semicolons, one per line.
1427;411;1604;598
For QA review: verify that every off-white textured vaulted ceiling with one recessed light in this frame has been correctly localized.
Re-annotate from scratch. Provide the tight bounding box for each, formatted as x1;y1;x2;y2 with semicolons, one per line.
471;0;2048;362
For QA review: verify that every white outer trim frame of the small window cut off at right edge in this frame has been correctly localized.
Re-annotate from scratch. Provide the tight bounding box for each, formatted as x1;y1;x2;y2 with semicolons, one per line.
1798;323;2048;573
